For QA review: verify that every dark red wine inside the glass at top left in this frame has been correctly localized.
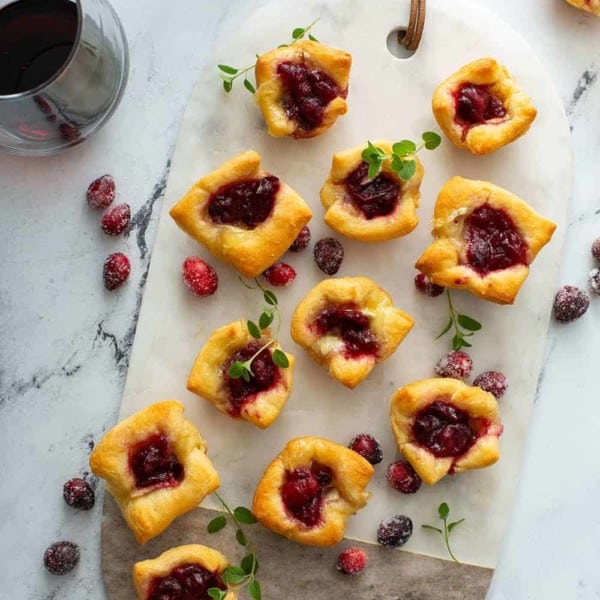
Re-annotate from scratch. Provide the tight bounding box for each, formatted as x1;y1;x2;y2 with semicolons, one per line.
0;0;78;95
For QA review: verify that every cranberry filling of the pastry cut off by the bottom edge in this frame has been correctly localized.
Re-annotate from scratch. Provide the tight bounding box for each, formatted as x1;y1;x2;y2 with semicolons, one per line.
148;563;227;600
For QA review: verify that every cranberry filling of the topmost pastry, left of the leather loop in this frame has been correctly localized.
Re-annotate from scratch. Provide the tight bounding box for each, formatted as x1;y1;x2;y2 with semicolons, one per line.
277;61;347;131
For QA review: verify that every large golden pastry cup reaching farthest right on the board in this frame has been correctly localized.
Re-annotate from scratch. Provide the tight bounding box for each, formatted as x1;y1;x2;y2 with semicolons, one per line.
415;177;556;304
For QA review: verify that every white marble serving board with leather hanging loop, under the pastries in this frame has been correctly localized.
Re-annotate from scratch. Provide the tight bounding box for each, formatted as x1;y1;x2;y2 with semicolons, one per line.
103;0;572;598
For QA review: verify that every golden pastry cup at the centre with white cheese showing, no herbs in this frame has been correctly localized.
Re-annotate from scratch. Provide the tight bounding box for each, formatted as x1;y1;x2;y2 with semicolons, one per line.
291;277;414;388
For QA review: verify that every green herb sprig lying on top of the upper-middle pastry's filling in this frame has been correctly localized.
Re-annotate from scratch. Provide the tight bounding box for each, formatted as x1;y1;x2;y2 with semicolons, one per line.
362;131;442;181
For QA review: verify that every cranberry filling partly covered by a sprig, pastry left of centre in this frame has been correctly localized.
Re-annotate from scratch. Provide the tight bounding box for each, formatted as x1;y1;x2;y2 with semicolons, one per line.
223;341;281;417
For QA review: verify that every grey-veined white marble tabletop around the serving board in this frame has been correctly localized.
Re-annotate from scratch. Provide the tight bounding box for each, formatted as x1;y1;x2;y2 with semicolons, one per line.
0;0;600;600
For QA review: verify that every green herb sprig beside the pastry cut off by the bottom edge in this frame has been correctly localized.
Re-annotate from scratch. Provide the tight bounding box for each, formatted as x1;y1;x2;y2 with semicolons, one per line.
206;492;261;600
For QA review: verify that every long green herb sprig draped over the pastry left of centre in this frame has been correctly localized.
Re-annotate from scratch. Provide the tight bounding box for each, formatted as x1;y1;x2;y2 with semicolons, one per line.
227;277;290;381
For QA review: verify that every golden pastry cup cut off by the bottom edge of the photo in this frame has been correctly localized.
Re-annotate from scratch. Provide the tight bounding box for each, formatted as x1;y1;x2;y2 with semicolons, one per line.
133;544;237;600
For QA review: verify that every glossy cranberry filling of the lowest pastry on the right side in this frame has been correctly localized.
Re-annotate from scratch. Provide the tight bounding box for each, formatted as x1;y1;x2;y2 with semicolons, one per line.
413;400;477;457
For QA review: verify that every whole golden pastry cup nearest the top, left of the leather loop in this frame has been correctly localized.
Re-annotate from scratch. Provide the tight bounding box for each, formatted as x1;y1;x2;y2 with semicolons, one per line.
255;40;352;138
